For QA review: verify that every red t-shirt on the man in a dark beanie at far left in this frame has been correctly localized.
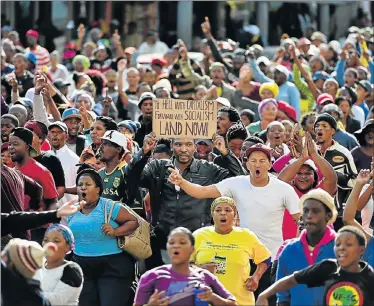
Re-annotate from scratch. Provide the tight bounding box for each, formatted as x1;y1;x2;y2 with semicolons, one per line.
18;158;58;210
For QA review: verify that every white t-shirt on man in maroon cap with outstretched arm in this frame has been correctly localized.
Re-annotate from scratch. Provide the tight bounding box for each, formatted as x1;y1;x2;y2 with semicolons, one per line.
215;175;300;260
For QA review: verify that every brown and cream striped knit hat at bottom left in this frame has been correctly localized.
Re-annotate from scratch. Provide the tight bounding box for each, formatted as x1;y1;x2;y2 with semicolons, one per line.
4;238;57;278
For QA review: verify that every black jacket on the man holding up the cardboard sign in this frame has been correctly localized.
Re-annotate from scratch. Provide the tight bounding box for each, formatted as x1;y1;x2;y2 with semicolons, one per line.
128;150;245;235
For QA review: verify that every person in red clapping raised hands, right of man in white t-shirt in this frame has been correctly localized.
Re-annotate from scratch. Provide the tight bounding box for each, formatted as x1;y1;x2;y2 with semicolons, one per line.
273;134;337;240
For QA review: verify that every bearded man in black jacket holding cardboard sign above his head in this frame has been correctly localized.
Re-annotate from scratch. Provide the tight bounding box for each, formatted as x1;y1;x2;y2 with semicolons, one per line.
128;134;244;269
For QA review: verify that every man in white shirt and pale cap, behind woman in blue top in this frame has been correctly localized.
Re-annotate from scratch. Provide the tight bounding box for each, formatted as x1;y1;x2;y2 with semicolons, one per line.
48;121;79;205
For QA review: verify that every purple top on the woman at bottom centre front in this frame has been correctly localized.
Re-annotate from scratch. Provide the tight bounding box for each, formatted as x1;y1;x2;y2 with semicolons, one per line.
135;265;235;306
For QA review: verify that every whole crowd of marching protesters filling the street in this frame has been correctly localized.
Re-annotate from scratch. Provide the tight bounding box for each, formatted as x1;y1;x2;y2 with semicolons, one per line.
1;13;374;306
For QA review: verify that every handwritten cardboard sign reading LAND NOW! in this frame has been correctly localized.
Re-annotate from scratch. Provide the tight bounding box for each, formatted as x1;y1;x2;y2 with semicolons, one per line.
153;99;217;139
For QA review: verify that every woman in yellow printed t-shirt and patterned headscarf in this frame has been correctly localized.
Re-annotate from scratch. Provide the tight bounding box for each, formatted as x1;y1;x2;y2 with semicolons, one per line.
191;197;271;305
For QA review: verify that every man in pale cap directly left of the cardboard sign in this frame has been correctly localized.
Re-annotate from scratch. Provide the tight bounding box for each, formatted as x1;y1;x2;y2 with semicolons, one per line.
135;92;156;145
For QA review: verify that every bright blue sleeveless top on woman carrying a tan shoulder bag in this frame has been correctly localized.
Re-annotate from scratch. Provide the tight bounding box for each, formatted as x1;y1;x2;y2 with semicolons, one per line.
68;198;122;257
